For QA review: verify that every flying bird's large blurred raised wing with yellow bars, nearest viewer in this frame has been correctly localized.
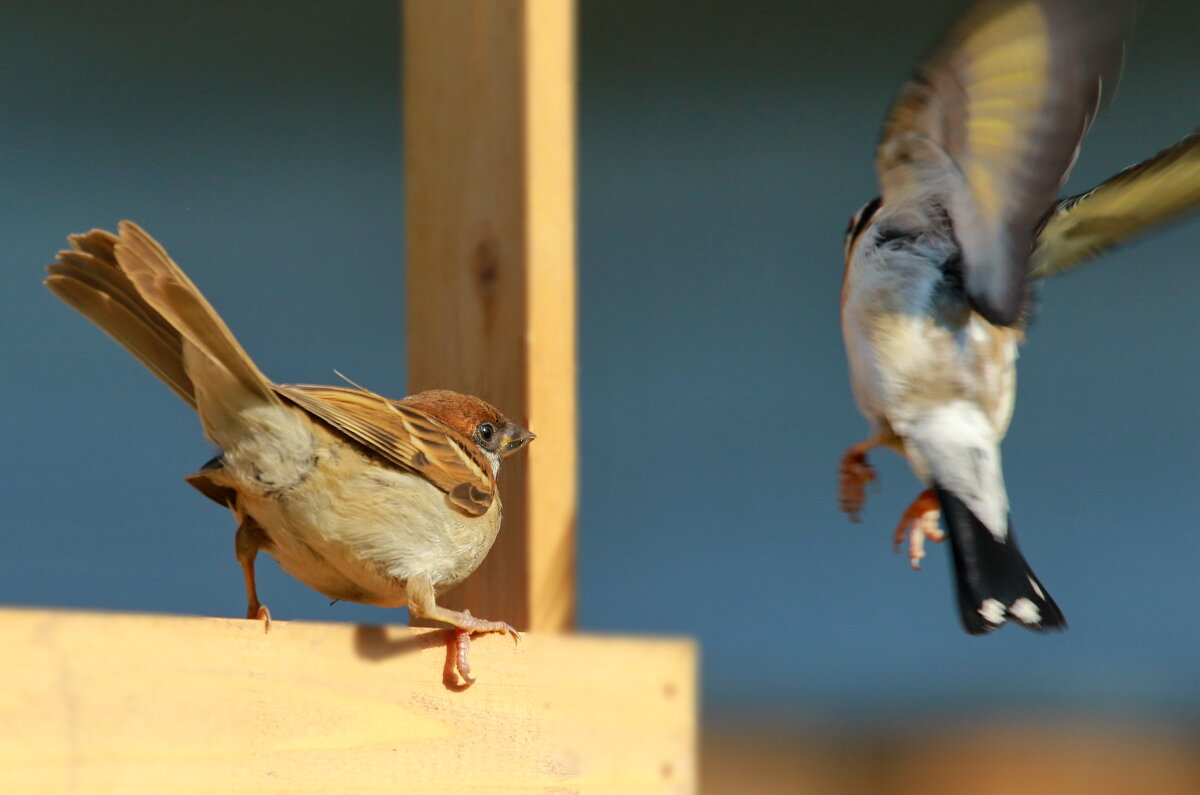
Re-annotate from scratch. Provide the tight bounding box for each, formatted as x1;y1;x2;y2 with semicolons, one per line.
876;0;1130;325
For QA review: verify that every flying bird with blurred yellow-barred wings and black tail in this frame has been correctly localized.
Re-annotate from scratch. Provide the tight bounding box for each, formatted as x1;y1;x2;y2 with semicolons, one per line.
840;0;1200;634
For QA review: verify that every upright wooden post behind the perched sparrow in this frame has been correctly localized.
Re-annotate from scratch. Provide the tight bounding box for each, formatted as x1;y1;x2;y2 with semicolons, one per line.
403;0;576;632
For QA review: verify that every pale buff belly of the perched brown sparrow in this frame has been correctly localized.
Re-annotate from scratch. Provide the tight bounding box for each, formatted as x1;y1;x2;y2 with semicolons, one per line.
240;442;500;608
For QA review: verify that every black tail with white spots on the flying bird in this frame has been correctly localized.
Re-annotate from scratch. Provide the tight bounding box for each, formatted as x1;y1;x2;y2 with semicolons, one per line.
934;483;1067;635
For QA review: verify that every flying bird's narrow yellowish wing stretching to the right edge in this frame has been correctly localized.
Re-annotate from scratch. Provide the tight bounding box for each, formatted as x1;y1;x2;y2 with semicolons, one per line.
1030;130;1200;277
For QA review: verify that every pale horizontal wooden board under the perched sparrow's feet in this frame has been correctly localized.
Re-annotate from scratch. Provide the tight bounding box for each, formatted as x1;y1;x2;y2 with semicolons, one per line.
0;609;696;793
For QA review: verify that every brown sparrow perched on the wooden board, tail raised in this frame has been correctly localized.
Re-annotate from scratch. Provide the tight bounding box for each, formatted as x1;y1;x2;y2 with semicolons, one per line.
46;221;533;679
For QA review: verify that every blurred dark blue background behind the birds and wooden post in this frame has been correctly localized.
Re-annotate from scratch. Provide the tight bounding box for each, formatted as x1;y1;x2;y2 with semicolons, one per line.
0;0;1200;744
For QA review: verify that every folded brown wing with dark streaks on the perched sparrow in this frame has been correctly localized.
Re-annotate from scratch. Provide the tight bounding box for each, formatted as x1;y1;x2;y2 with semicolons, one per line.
275;384;496;516
